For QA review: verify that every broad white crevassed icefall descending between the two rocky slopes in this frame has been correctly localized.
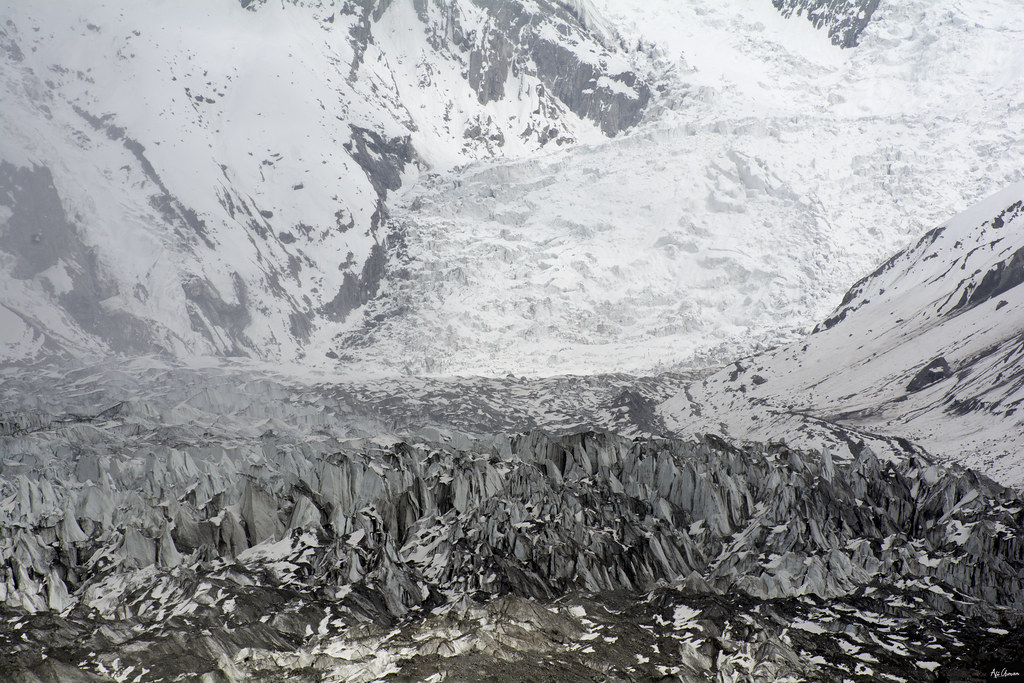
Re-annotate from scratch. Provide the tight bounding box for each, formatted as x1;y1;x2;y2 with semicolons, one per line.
332;0;1024;376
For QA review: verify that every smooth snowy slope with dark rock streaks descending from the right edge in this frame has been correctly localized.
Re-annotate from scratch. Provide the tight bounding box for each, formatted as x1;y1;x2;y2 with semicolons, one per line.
662;183;1024;486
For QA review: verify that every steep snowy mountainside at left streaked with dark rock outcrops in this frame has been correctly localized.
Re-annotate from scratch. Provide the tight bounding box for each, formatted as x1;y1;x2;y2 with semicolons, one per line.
0;0;648;366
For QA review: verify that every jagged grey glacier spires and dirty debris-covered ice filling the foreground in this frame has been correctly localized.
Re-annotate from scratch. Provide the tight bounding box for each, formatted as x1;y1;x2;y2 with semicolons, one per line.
0;374;1024;681
